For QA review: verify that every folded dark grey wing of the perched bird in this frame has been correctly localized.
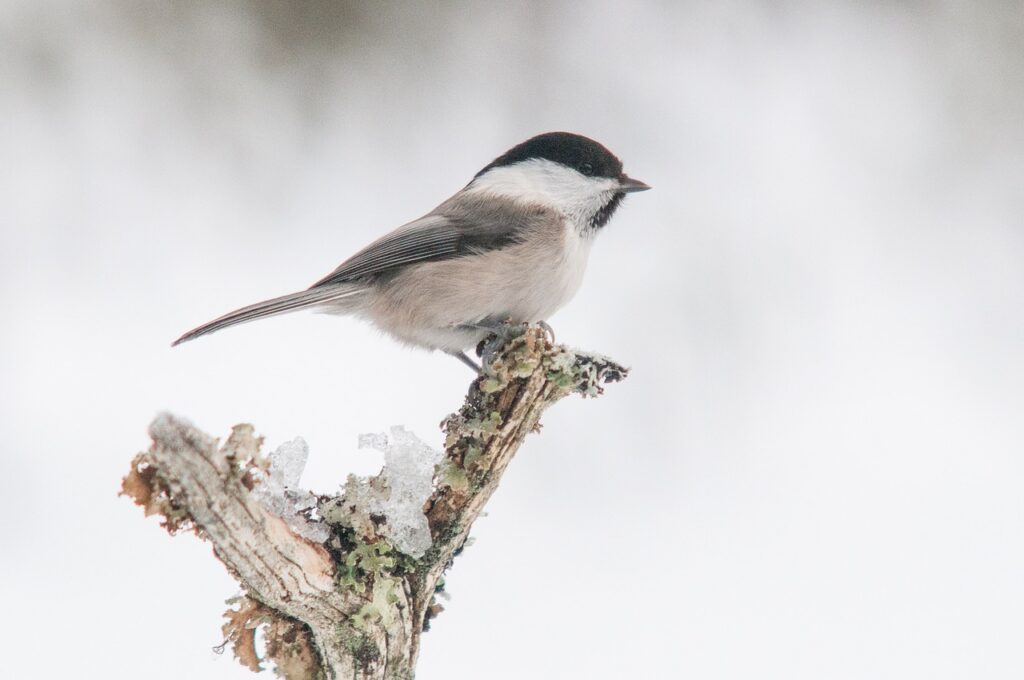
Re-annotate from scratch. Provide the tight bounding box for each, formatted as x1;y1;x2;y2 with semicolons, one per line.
310;197;548;289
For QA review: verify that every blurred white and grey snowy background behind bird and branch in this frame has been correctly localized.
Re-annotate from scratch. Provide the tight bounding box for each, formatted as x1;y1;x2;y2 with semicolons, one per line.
0;0;1024;680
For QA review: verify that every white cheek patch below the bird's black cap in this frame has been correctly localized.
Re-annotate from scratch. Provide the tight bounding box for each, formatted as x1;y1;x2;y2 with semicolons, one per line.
466;159;618;220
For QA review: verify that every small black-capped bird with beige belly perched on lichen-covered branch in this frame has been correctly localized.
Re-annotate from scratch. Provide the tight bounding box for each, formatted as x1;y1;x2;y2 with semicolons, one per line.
174;132;650;370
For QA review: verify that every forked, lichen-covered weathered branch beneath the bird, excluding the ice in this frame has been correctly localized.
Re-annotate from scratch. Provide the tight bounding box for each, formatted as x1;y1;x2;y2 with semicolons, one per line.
123;327;627;680
